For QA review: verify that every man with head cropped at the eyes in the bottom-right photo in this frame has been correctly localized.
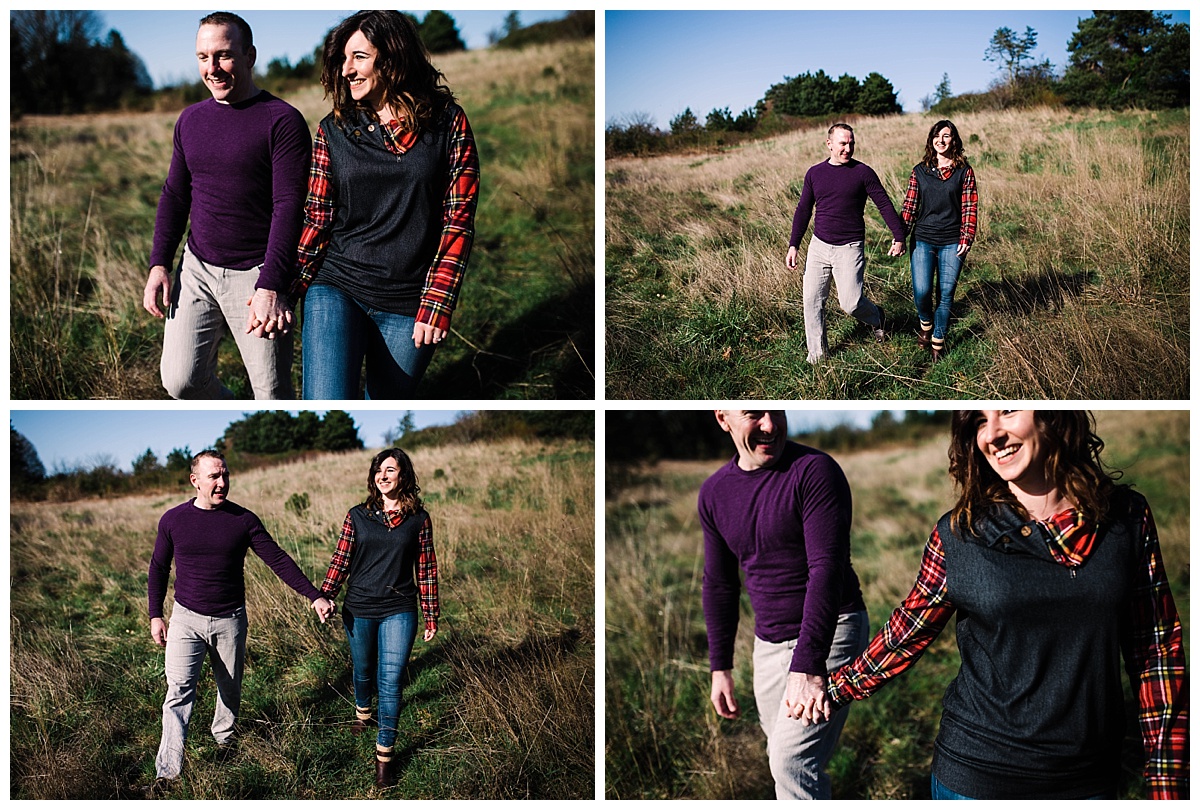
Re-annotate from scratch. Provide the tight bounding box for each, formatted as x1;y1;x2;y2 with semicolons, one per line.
700;410;869;799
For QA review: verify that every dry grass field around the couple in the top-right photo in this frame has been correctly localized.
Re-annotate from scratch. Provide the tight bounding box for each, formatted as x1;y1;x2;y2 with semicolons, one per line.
605;109;1190;400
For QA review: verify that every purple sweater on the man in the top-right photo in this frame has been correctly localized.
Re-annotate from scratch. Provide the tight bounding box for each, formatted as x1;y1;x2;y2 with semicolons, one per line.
787;160;905;247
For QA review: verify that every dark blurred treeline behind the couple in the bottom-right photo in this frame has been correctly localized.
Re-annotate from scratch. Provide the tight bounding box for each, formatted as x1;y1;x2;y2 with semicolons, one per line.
605;410;950;467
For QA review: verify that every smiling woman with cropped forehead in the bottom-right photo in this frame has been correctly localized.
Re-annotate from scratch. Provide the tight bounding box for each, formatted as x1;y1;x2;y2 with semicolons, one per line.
793;410;1188;799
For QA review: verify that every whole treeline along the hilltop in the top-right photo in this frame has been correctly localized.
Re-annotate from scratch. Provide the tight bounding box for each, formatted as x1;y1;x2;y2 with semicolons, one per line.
605;11;1192;156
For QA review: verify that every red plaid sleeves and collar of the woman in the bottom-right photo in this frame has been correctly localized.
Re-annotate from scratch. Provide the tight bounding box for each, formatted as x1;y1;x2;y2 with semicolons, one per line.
828;506;1188;799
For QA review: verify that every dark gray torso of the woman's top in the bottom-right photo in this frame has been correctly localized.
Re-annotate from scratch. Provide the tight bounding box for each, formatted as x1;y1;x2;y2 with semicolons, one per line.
934;488;1145;799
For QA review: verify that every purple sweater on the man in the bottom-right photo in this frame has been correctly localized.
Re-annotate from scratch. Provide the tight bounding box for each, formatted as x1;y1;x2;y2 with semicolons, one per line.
700;442;864;674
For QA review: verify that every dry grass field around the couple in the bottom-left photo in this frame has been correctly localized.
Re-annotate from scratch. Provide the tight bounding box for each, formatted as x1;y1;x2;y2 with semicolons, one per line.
10;440;595;800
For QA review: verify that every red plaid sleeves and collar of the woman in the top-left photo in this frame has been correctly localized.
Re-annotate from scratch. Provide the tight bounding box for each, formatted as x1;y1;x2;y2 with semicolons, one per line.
292;108;479;330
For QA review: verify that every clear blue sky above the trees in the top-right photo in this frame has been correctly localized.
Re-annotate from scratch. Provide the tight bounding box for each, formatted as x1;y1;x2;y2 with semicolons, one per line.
604;11;1190;130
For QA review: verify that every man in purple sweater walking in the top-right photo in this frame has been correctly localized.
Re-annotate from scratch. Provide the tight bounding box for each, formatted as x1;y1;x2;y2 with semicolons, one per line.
787;124;905;364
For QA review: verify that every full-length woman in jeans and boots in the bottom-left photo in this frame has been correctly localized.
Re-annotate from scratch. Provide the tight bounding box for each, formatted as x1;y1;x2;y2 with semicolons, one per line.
322;448;438;787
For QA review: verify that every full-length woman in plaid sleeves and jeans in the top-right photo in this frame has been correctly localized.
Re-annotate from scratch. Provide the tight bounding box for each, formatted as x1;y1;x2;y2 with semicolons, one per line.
900;121;979;362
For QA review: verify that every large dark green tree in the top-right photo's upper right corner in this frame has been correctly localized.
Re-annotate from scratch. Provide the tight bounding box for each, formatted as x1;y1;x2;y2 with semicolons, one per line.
1062;11;1192;108
